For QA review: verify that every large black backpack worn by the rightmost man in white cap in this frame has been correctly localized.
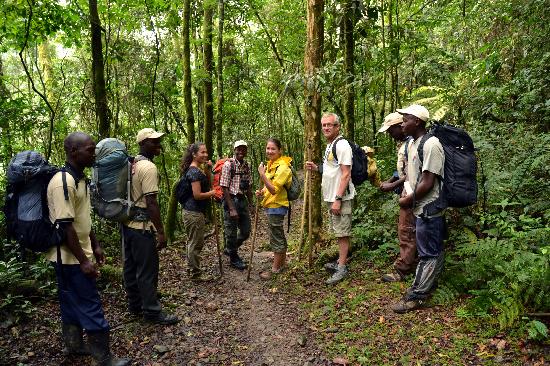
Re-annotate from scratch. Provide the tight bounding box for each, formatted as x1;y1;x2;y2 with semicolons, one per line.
418;123;477;215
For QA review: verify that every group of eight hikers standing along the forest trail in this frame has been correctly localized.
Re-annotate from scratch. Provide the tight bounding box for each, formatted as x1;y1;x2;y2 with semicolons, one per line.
23;101;445;365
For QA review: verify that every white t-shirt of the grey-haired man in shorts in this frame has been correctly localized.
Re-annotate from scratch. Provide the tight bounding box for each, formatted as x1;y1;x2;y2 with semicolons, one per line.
321;136;355;202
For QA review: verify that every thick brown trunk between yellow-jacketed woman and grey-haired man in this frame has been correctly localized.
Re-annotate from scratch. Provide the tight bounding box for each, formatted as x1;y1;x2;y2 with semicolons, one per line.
304;0;324;258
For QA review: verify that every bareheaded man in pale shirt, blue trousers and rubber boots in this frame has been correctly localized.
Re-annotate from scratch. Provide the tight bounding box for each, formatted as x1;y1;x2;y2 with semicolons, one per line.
47;132;130;366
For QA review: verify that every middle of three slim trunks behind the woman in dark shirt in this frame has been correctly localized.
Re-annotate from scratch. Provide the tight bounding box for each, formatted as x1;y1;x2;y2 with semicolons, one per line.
202;0;214;154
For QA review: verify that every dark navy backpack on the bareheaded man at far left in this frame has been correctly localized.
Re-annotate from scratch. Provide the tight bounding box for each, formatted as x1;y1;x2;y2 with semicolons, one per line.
3;150;69;252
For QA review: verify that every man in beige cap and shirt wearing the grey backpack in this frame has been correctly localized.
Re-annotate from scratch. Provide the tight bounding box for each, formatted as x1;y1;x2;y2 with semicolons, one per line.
122;128;179;325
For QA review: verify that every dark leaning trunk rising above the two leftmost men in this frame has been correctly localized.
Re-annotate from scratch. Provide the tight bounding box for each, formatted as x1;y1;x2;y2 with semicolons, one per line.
88;0;111;139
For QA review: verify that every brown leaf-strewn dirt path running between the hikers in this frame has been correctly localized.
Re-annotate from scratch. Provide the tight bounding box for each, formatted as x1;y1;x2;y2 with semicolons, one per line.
0;202;328;366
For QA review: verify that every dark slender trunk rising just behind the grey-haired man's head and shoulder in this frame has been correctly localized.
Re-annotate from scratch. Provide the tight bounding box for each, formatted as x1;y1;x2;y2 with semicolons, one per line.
343;0;355;140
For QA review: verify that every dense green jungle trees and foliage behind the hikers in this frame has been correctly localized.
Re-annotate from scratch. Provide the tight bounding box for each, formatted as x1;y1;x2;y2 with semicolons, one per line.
0;0;550;360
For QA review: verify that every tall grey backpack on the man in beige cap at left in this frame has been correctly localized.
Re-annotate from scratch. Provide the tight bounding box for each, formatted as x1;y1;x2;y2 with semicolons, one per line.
90;138;149;222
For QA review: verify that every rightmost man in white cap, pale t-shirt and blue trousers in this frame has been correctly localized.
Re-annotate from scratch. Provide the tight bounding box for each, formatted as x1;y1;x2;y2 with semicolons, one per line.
392;104;446;313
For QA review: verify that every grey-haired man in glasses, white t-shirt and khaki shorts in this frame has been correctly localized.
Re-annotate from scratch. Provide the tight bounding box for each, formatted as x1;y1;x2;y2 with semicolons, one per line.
306;113;355;285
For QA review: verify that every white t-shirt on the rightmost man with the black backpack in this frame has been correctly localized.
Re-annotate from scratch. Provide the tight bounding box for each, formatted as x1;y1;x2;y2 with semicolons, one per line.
407;136;445;217
